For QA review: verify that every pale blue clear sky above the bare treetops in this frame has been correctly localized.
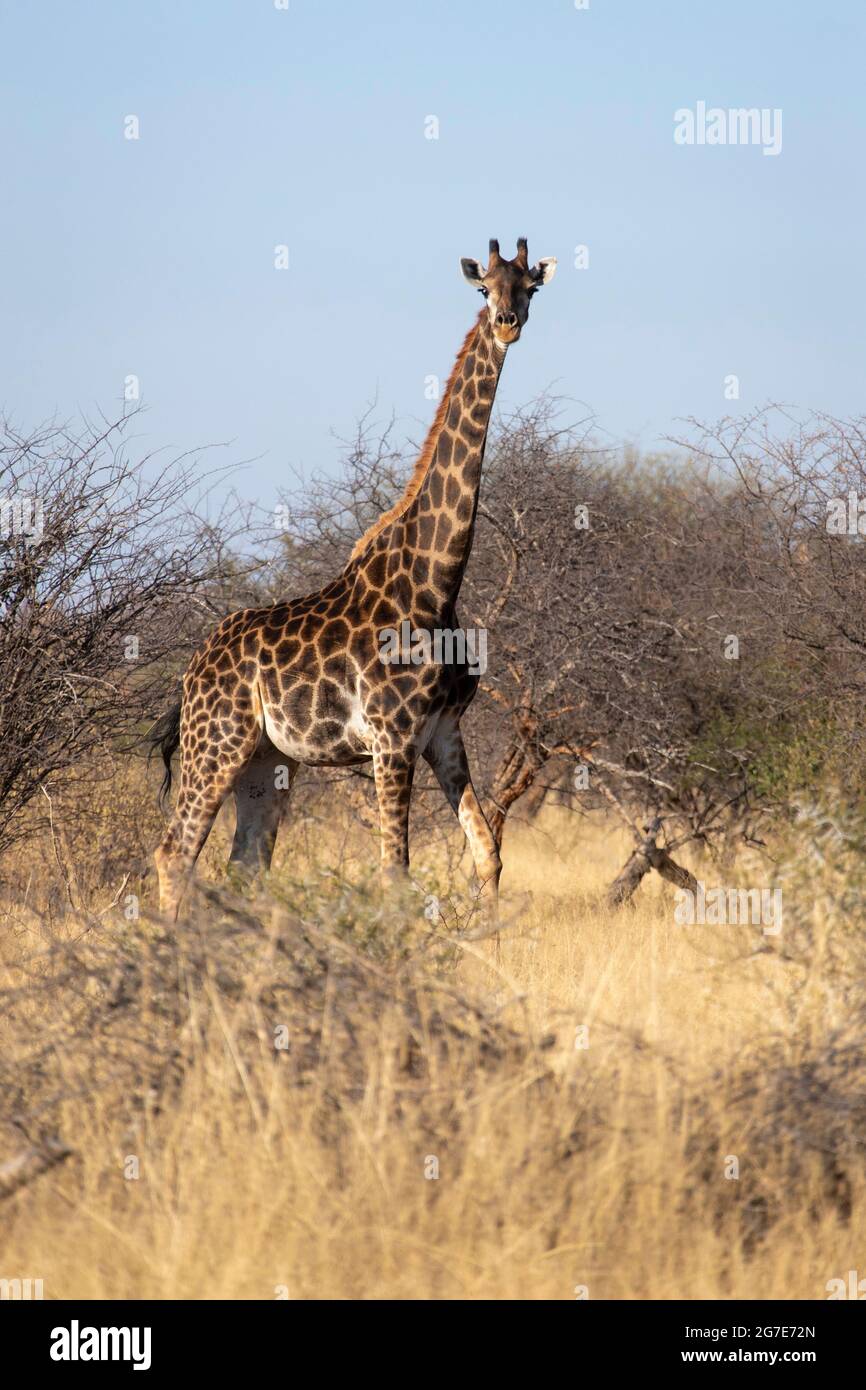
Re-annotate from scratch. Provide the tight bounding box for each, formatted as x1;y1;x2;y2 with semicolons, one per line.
0;0;866;502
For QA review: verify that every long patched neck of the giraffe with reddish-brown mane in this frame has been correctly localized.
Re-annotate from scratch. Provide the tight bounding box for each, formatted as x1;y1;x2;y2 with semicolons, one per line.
392;310;505;610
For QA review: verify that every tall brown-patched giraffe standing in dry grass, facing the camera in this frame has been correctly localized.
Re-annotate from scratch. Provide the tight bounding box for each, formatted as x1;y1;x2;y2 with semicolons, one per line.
150;238;556;917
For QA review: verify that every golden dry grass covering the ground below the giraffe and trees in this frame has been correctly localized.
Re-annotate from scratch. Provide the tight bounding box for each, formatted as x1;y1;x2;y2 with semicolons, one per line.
0;783;866;1298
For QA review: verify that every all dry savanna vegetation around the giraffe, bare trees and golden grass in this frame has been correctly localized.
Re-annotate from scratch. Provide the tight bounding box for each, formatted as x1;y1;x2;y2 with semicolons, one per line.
0;399;866;1298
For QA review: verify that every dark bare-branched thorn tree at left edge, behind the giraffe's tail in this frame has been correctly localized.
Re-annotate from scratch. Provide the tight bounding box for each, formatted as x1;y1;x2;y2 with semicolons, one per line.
0;414;240;851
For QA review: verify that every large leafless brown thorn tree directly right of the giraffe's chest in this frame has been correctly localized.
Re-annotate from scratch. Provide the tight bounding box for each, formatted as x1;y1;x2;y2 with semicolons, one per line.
467;406;839;904
